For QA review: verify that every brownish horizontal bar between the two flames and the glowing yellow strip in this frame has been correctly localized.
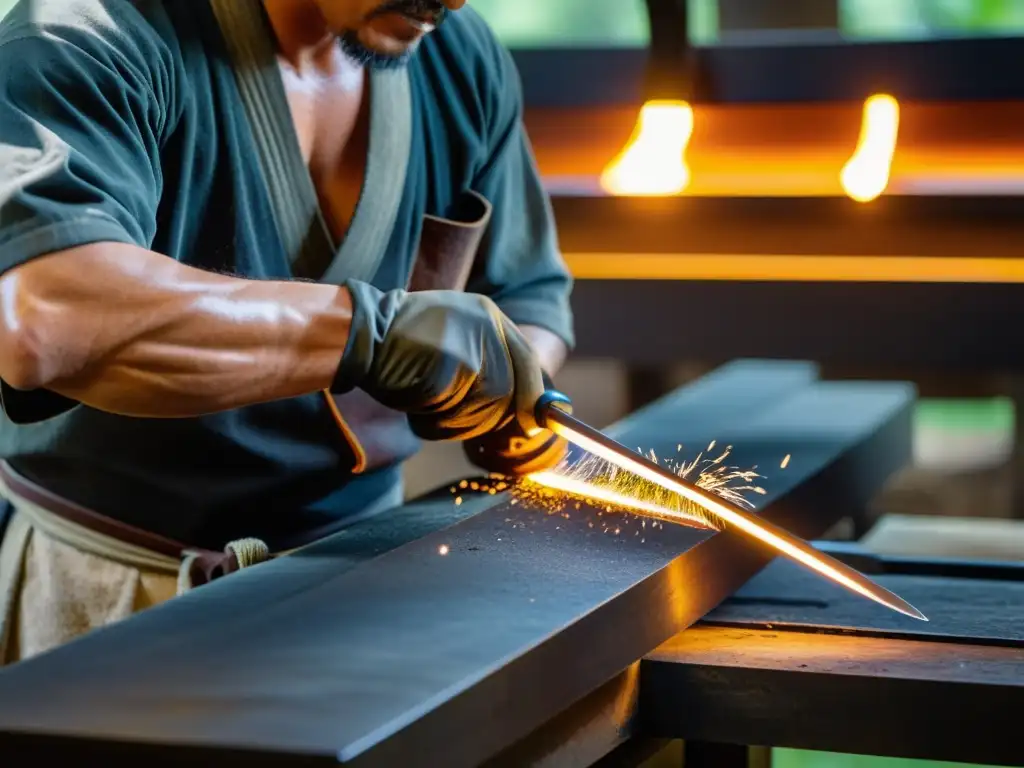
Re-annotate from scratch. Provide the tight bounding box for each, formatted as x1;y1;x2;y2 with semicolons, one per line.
553;195;1024;258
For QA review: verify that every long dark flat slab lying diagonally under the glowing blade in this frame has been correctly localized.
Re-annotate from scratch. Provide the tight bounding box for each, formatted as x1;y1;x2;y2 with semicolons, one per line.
0;362;913;768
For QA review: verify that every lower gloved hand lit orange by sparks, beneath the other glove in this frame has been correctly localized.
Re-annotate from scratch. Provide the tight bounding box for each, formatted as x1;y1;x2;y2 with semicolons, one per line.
463;376;568;477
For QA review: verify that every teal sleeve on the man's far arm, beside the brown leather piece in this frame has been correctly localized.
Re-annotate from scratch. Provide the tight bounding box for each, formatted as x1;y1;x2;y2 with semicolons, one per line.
468;46;574;348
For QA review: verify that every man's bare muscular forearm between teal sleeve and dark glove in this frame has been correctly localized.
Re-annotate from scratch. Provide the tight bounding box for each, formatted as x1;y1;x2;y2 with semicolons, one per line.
0;244;351;417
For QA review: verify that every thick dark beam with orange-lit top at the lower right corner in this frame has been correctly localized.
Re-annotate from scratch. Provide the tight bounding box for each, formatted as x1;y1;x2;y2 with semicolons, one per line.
640;626;1024;766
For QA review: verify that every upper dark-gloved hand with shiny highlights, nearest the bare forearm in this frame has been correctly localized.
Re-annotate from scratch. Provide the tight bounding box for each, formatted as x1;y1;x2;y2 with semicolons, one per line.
332;281;544;440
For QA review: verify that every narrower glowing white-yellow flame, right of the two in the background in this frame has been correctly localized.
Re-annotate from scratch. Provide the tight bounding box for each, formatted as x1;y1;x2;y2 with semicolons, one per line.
840;94;899;203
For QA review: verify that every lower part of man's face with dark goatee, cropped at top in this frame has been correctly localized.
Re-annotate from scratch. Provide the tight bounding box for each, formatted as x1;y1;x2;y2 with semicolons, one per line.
316;0;466;69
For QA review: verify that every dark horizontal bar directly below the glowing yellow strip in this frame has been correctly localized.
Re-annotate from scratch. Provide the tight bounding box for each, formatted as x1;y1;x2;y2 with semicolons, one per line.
572;280;1024;372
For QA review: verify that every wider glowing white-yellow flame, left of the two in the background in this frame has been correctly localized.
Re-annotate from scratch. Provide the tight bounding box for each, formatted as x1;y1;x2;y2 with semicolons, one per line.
601;100;693;196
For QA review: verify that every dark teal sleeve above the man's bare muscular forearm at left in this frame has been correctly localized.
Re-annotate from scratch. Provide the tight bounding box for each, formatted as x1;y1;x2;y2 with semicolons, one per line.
0;21;161;280
